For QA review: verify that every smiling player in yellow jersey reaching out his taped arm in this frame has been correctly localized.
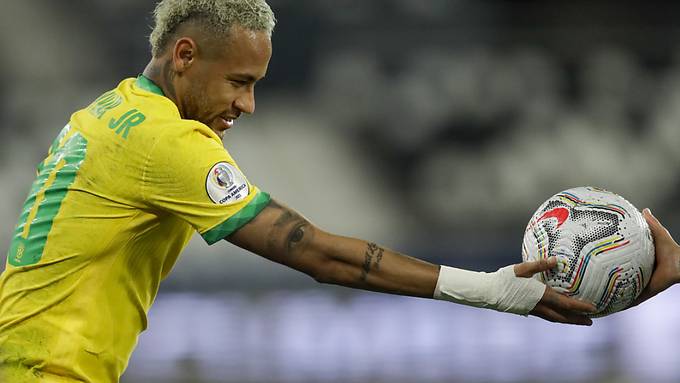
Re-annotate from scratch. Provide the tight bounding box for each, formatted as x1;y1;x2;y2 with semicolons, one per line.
0;0;664;383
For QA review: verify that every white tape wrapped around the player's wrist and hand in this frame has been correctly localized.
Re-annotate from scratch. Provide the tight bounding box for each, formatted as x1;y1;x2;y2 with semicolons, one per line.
434;266;545;315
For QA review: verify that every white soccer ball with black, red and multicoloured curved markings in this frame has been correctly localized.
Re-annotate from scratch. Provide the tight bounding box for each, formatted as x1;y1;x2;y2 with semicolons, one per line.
522;187;654;317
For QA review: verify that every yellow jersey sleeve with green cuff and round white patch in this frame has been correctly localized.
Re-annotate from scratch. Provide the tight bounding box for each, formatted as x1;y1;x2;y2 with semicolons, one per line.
143;127;270;245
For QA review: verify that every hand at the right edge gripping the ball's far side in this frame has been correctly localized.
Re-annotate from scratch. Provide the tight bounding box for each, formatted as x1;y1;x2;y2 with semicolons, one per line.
633;209;680;306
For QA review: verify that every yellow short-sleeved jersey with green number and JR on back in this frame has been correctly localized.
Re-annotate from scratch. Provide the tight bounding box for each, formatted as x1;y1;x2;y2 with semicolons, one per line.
0;76;269;383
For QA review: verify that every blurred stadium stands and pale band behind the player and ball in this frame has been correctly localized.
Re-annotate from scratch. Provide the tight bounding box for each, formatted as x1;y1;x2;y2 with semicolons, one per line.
0;0;680;383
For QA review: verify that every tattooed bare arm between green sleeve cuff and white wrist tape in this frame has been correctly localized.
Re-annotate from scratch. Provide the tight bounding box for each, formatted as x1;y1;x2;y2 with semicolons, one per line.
228;199;439;298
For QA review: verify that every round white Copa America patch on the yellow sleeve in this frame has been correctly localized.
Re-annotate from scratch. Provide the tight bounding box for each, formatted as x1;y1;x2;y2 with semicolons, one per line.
205;162;250;205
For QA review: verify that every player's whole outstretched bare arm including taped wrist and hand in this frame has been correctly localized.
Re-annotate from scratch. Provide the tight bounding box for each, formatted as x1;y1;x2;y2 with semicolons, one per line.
227;199;594;324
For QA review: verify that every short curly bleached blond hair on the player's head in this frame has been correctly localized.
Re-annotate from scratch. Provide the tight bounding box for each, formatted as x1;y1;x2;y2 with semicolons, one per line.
149;0;276;57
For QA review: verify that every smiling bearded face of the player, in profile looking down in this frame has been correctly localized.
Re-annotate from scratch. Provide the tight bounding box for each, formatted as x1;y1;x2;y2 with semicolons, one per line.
176;26;272;138
